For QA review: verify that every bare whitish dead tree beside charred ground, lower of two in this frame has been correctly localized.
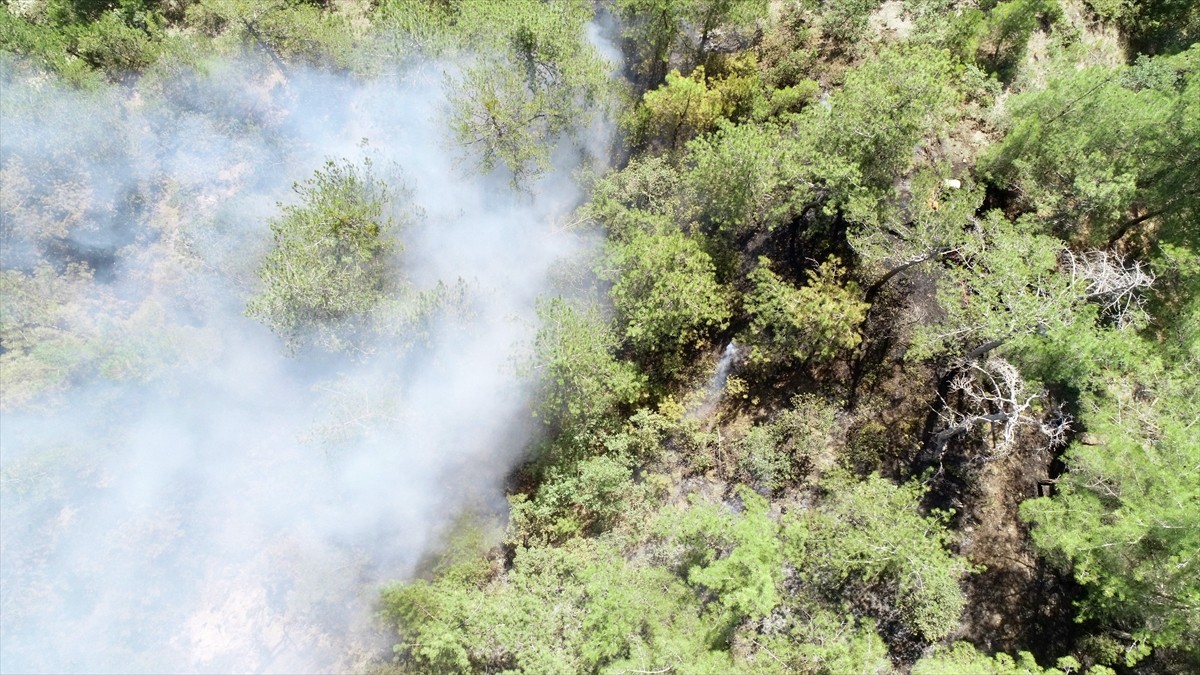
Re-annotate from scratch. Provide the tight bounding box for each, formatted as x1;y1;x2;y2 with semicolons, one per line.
934;357;1070;460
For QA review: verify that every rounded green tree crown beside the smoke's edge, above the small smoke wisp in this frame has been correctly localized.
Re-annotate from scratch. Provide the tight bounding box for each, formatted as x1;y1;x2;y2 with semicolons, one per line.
601;225;730;358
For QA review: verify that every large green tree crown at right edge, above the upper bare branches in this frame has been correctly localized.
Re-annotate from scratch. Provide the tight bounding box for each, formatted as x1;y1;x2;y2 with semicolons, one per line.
980;48;1200;244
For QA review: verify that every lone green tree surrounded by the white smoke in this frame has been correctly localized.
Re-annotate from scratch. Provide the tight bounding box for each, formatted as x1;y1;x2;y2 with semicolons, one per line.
246;160;404;351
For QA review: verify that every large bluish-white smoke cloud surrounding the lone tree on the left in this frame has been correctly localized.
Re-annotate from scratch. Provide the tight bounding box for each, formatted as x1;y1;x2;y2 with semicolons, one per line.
0;48;609;671
